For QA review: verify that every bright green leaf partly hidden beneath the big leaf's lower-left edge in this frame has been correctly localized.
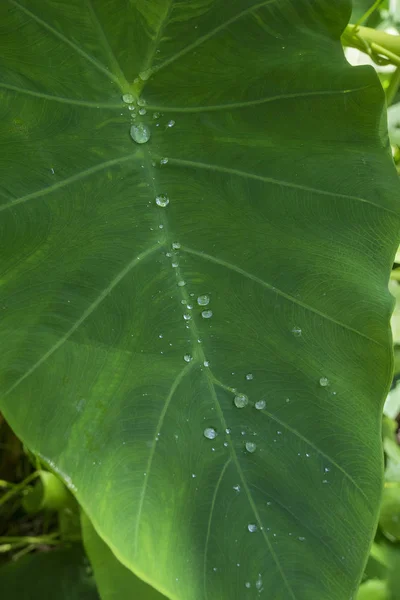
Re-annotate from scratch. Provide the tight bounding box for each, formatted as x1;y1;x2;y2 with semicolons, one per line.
82;514;165;600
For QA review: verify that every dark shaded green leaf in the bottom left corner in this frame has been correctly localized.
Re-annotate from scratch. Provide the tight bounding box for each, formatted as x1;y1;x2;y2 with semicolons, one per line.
0;544;99;600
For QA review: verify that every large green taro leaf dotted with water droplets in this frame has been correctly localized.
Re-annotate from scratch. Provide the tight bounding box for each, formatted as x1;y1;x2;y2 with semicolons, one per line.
0;0;400;600
